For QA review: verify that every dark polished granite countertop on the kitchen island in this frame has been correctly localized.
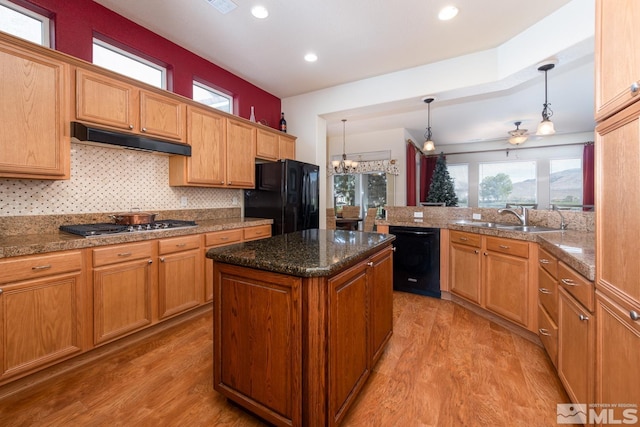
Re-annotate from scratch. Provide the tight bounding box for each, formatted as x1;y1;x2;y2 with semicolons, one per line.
207;229;395;277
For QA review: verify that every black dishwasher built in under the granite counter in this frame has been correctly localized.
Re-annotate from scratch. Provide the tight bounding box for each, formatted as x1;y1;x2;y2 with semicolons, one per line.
389;226;440;298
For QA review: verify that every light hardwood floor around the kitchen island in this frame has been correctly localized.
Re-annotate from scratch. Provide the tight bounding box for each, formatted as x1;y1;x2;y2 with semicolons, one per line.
0;292;568;427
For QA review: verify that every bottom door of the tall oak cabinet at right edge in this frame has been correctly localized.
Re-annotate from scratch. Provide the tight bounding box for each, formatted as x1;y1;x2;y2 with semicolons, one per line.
594;292;640;412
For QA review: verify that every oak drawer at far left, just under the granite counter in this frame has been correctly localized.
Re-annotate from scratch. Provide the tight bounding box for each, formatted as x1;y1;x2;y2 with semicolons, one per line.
0;251;82;283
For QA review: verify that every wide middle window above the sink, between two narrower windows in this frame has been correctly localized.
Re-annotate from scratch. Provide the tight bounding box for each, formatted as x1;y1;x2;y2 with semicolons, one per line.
478;161;537;208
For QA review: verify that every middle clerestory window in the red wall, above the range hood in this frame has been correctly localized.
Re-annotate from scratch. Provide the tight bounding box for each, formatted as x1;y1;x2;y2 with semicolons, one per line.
93;38;167;89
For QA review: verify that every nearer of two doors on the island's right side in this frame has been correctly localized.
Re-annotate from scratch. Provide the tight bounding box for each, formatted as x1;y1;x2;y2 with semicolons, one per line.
328;262;370;425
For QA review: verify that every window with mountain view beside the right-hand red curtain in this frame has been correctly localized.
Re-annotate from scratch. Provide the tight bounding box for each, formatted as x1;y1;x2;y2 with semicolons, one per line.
549;159;582;206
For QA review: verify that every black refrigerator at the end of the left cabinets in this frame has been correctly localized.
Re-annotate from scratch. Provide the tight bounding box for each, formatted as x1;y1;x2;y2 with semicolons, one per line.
244;160;320;236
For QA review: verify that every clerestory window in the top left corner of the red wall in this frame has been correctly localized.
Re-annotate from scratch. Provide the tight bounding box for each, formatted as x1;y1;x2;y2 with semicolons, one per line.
0;0;50;47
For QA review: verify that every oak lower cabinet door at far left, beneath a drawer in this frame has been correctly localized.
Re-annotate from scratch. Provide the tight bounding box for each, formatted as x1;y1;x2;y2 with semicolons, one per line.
0;271;85;380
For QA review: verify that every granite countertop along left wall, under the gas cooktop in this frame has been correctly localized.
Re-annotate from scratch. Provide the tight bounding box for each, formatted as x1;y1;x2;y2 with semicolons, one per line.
0;217;273;258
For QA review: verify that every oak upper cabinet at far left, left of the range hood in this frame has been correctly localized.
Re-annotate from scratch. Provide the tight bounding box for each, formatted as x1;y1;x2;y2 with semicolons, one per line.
0;37;70;179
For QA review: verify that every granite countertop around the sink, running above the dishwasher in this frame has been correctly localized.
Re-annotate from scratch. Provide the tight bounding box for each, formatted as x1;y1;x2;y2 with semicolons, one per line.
376;220;596;281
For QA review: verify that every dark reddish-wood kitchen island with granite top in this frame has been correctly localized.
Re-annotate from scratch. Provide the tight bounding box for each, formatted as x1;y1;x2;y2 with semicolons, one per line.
207;230;394;426
